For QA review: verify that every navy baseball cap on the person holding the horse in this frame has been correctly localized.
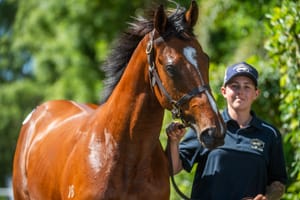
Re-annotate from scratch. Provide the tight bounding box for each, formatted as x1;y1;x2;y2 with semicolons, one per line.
224;62;258;86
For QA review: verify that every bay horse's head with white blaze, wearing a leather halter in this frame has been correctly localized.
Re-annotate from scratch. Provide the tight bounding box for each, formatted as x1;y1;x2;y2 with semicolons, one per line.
146;1;225;149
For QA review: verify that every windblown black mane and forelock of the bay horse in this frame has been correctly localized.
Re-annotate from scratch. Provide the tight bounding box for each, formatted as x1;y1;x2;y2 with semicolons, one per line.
100;5;193;104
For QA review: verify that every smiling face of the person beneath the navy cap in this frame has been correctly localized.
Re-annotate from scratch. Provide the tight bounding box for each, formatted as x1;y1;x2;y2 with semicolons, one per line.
221;76;259;112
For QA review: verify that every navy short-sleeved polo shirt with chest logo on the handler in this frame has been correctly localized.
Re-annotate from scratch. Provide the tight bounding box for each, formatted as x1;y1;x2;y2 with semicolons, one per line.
179;110;287;200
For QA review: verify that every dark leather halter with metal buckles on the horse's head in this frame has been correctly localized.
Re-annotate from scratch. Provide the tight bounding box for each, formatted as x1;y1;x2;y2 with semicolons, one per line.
146;30;210;126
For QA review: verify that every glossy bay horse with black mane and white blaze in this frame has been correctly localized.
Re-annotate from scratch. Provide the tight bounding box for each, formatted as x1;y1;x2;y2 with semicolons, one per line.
13;1;225;200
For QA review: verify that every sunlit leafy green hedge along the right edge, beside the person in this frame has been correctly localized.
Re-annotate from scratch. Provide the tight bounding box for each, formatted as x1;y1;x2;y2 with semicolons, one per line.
265;0;300;199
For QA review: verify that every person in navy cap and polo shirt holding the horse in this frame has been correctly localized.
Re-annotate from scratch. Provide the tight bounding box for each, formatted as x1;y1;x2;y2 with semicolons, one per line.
167;62;287;200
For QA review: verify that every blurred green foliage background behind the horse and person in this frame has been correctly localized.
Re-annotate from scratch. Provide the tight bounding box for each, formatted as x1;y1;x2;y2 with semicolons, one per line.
0;0;300;200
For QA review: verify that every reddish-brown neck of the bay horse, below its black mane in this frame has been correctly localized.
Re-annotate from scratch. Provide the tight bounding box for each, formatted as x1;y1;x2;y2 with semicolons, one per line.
96;39;164;148
